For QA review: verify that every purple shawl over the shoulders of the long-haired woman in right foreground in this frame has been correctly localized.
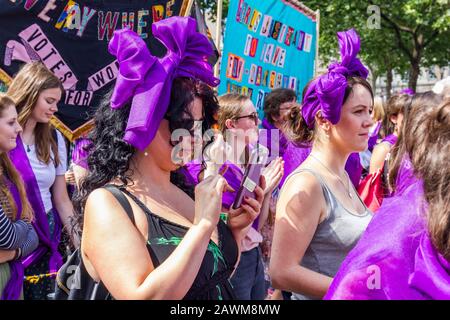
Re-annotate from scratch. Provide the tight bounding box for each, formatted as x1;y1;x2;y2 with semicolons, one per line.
324;181;450;300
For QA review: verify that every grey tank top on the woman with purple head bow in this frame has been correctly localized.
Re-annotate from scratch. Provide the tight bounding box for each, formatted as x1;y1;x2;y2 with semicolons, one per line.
288;169;372;300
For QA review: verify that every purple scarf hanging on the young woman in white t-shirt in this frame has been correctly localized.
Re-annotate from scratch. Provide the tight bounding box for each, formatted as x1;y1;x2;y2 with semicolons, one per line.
9;136;62;278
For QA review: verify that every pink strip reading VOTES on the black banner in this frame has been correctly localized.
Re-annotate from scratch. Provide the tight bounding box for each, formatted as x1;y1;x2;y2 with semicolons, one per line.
19;24;78;89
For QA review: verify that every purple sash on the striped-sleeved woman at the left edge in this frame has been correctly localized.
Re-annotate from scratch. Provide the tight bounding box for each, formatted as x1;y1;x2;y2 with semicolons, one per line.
1;178;24;300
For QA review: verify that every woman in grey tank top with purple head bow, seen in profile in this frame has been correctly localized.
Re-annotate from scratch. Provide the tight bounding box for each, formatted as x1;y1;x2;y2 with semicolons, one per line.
270;29;373;300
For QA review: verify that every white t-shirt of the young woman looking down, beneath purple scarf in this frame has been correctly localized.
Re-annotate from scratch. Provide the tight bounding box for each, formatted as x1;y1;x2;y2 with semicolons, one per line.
23;131;67;212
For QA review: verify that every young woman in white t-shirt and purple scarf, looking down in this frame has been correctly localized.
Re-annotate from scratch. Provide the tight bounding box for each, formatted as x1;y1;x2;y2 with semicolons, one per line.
8;62;77;300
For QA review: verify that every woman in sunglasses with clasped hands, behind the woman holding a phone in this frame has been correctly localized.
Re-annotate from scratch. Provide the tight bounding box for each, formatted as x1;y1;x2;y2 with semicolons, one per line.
208;94;283;300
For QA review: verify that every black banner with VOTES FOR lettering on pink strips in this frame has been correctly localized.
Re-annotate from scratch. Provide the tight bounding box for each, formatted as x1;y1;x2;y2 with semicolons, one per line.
0;0;188;141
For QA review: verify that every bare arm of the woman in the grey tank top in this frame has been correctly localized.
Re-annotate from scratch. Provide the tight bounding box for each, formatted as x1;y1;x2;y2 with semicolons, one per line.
270;173;333;298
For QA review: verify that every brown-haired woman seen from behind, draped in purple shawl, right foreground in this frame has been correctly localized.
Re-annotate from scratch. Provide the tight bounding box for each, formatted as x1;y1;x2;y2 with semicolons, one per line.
326;93;450;300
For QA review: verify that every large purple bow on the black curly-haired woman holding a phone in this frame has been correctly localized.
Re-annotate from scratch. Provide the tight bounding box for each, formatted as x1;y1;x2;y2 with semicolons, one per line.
109;17;219;151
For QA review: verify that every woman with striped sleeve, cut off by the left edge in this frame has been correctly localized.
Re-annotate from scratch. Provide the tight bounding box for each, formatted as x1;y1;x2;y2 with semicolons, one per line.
0;93;39;300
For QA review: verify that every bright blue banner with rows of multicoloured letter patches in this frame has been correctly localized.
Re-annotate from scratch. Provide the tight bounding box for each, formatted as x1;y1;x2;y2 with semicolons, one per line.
219;0;317;116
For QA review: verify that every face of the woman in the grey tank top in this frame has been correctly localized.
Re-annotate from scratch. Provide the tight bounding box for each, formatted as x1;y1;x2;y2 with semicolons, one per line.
330;84;373;153
